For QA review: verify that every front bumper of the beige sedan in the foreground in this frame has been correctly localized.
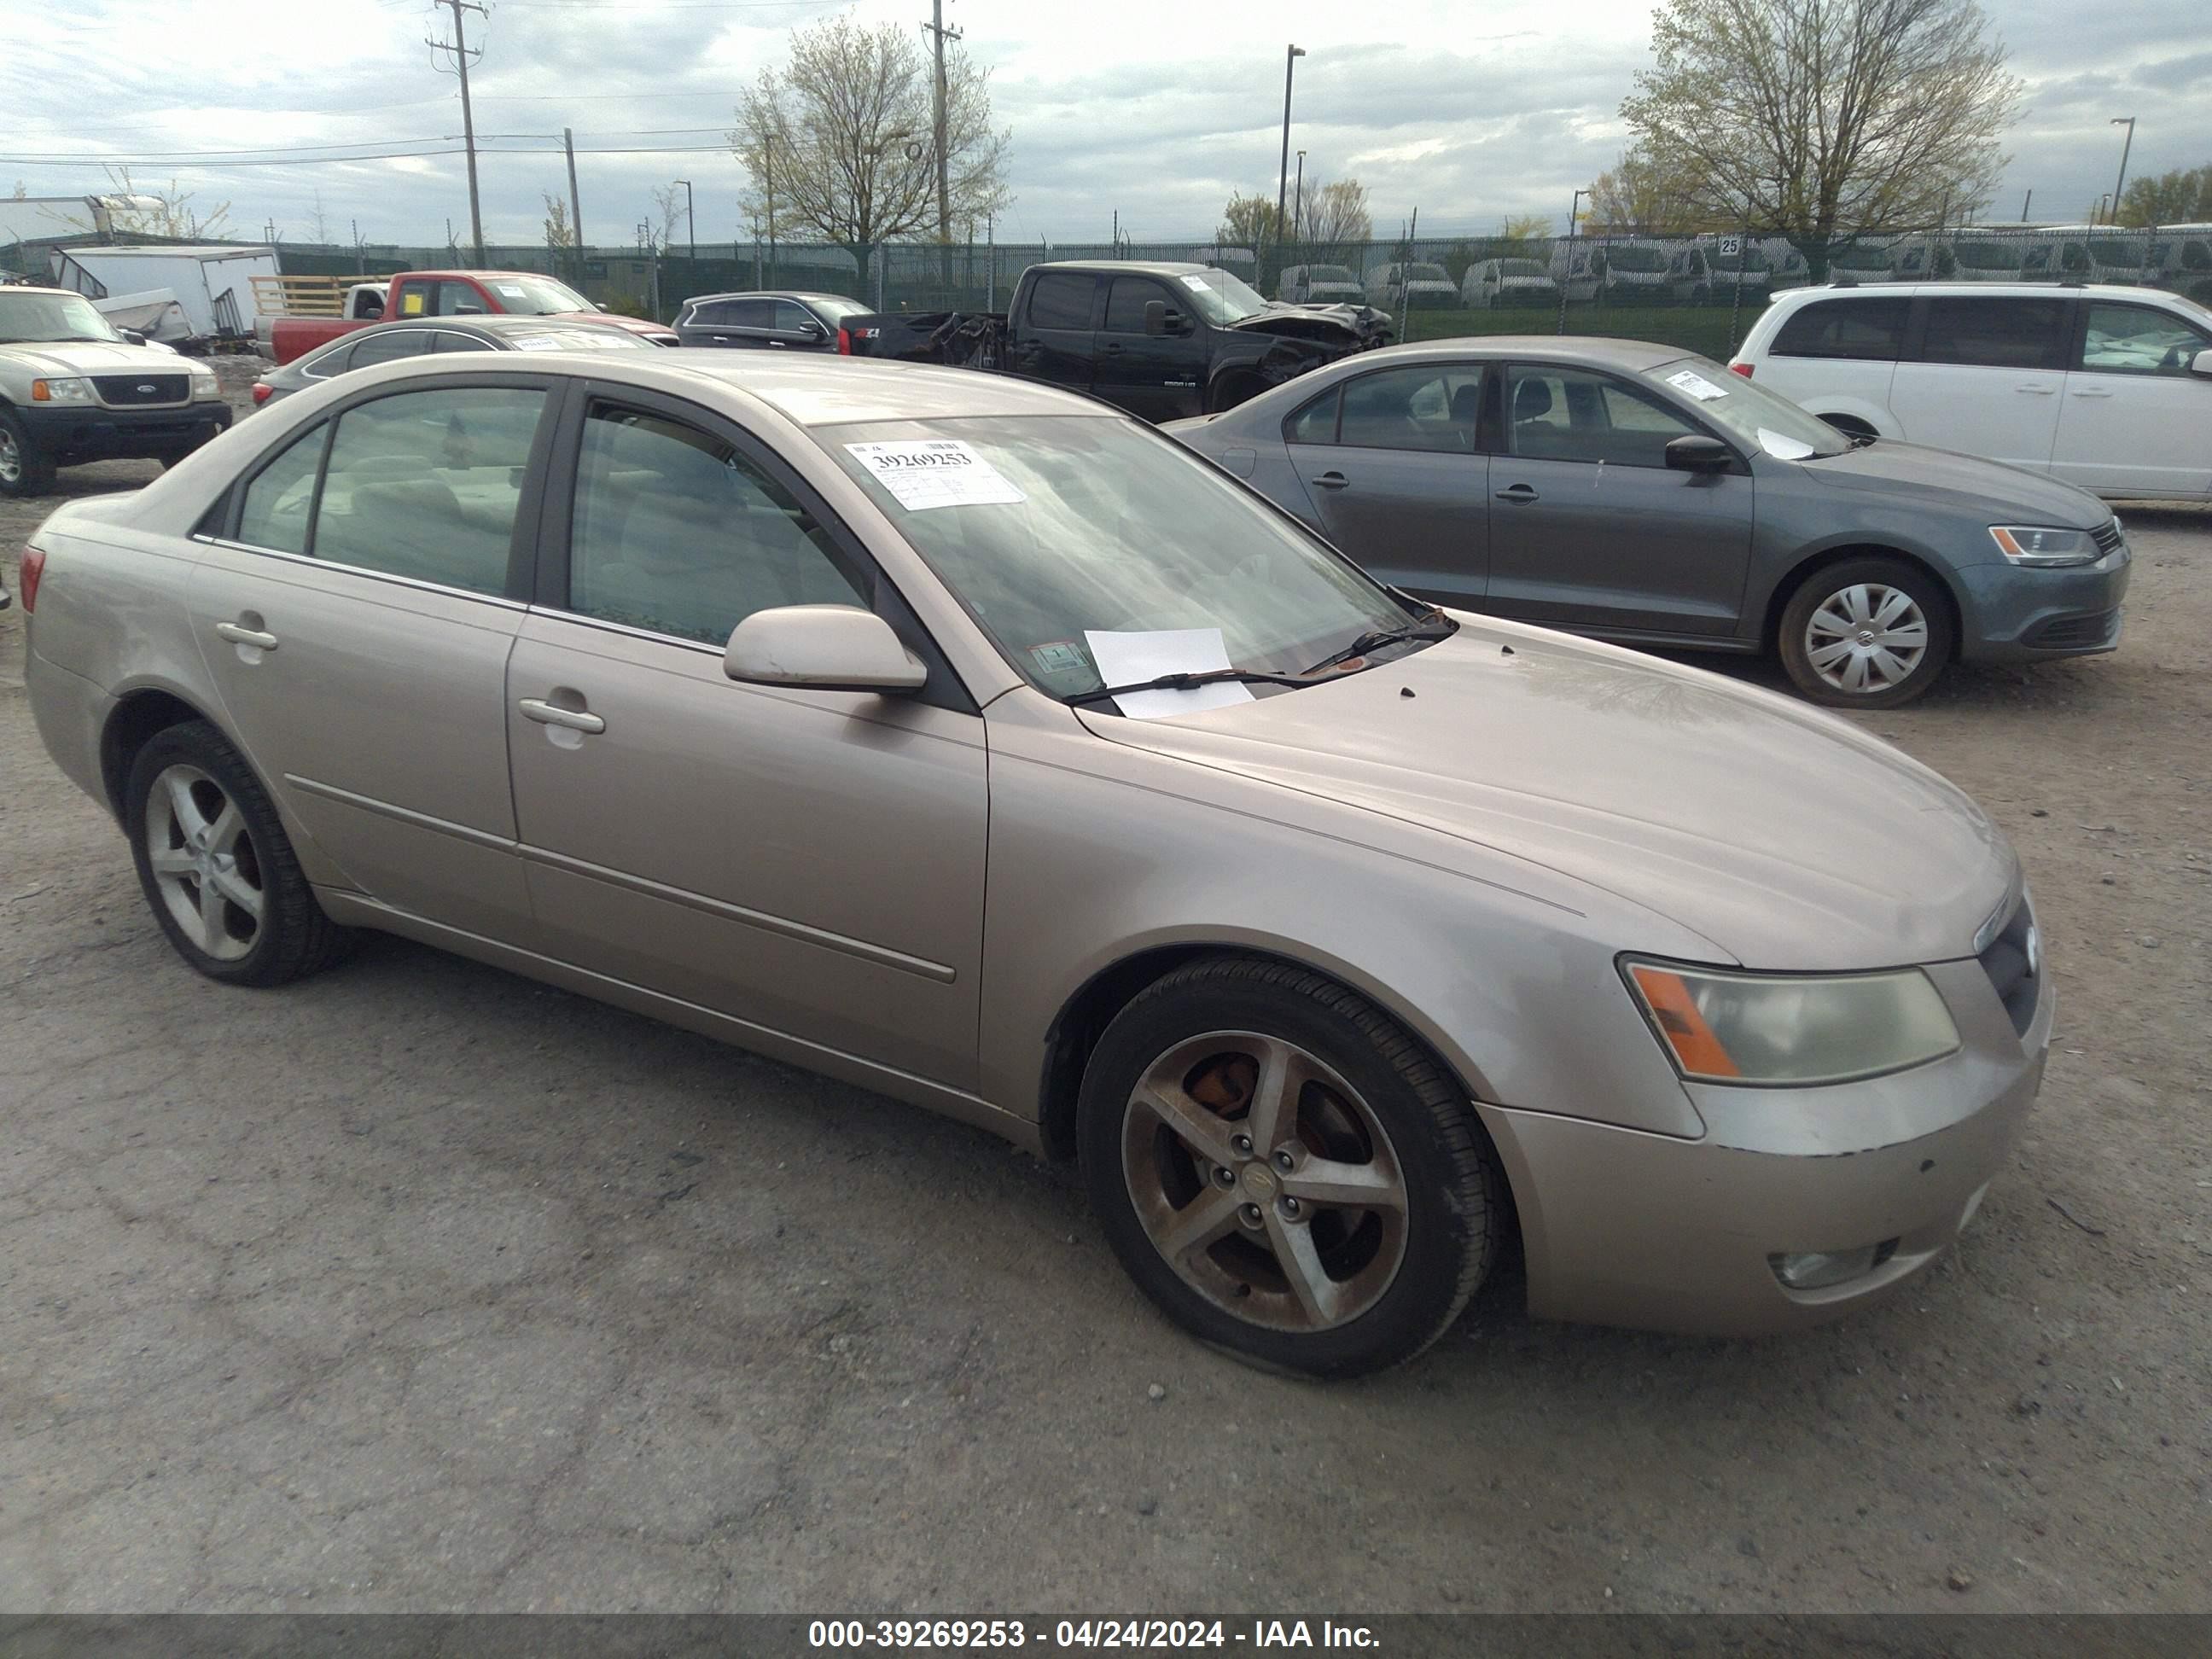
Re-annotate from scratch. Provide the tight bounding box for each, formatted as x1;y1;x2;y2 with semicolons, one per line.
1477;958;2052;1336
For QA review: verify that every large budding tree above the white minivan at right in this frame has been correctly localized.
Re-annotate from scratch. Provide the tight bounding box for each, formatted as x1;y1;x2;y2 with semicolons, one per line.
1621;0;2019;263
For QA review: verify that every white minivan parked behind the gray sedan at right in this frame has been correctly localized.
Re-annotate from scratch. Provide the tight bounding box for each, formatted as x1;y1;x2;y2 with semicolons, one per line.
1727;283;2212;500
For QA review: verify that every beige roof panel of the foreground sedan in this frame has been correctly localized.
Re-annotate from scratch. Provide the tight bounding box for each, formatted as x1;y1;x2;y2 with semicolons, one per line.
323;345;1128;427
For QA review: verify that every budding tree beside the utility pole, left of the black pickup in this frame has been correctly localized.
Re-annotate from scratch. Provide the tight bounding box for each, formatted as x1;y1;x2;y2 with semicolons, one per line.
728;15;1013;281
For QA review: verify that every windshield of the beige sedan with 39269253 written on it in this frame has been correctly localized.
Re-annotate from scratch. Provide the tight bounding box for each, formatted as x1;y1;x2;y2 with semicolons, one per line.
814;416;1416;696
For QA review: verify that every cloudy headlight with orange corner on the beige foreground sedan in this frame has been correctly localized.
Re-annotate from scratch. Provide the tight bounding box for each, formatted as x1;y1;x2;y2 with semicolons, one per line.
1621;960;1958;1084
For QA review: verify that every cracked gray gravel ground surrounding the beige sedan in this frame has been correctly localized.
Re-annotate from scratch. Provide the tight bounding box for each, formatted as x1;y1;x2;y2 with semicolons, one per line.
0;365;2212;1613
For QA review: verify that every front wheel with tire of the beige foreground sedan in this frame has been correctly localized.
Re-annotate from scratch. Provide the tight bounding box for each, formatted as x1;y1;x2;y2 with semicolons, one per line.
1077;956;1506;1376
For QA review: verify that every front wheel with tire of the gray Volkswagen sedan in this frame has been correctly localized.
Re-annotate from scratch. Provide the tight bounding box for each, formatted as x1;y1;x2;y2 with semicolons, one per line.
1774;560;1953;707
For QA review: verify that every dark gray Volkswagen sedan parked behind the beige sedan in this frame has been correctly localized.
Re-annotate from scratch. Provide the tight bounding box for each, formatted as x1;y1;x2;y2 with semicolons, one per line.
1166;336;2128;707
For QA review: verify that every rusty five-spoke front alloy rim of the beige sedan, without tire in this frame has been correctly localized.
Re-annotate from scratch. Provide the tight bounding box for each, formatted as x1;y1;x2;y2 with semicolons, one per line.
1121;1031;1409;1331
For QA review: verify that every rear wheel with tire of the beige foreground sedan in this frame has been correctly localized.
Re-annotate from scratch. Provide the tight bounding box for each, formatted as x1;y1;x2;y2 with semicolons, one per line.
124;721;352;987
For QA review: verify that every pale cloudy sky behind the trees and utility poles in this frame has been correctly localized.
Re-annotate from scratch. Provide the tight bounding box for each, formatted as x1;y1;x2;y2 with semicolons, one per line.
0;0;2212;243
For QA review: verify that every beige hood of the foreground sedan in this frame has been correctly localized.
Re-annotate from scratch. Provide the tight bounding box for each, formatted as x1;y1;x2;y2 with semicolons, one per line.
1080;615;2017;971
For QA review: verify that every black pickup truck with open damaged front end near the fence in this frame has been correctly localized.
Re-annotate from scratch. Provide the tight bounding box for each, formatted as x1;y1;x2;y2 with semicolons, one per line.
843;259;1391;420
